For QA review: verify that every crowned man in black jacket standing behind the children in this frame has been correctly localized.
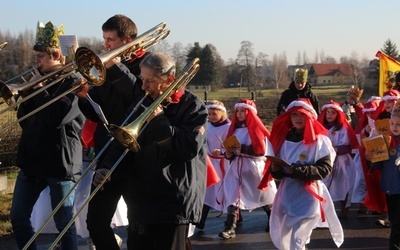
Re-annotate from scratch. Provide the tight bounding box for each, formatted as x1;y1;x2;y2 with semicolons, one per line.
277;69;319;116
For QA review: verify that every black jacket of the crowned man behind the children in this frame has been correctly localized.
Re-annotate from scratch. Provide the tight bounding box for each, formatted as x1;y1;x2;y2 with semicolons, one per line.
277;81;319;115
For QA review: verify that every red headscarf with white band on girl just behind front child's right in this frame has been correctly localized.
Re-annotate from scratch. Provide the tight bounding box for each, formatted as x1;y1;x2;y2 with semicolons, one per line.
318;101;359;149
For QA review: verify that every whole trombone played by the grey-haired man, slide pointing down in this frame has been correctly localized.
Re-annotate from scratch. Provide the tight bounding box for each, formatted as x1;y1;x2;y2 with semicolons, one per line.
47;58;200;249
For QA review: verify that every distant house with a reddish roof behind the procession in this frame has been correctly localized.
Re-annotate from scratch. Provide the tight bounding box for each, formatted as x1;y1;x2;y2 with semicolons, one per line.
308;63;353;85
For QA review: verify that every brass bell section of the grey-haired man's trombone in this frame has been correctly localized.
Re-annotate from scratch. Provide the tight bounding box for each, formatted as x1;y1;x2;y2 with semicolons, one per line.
110;58;199;152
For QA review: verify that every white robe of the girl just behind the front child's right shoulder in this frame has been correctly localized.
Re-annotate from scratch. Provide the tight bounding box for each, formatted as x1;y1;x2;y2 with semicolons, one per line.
322;127;356;207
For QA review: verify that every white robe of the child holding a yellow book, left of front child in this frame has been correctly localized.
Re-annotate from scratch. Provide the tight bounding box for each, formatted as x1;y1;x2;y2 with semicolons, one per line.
223;128;276;212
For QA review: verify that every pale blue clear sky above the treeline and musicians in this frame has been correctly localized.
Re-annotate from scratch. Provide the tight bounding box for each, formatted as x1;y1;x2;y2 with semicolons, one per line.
0;0;400;64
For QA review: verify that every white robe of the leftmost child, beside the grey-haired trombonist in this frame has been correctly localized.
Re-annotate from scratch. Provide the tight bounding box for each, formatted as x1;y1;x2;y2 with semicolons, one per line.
204;123;230;211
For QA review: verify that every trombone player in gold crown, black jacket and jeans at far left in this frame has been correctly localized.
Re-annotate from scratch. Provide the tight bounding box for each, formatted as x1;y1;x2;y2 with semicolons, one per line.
10;22;85;250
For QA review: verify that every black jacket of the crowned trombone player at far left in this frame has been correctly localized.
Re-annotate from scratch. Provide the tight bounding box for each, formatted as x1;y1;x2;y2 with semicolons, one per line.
17;78;85;180
